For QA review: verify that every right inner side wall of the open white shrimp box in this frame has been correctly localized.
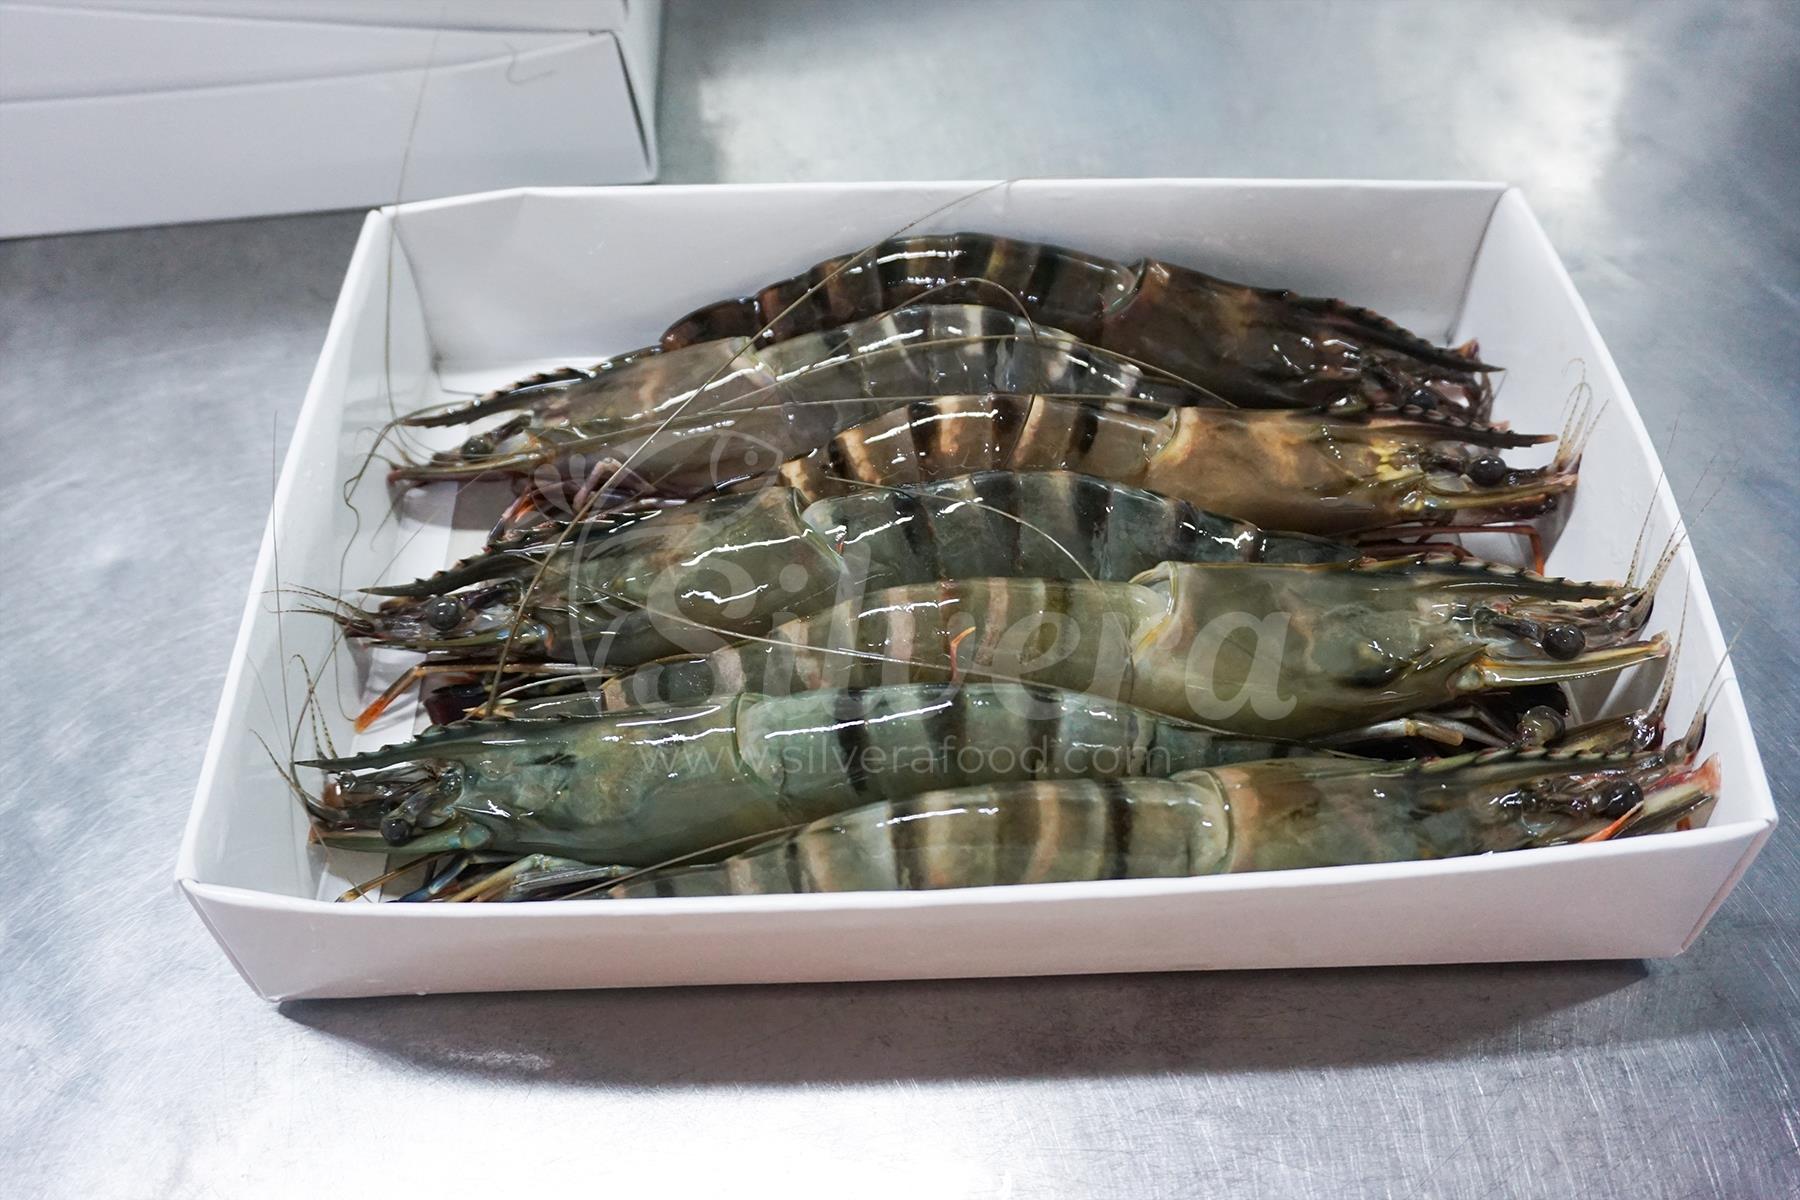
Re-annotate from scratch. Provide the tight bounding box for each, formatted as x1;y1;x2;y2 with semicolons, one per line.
1456;191;1775;824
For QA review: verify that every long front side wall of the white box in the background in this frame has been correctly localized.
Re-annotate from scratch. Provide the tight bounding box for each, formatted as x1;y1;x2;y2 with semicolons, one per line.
0;34;652;237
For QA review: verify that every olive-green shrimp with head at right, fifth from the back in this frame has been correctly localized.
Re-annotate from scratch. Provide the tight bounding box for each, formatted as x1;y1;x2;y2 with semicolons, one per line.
500;556;1667;739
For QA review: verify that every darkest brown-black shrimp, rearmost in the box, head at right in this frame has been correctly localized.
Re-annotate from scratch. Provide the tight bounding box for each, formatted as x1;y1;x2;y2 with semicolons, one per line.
661;234;1496;421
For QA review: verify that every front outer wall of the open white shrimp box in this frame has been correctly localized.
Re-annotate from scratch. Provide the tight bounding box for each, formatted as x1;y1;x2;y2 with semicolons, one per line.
196;831;1755;1000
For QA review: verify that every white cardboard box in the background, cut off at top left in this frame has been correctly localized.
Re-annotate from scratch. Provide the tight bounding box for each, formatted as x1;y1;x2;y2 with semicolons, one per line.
0;0;661;237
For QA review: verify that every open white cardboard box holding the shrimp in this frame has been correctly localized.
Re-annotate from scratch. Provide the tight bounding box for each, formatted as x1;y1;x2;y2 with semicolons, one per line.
176;180;1775;999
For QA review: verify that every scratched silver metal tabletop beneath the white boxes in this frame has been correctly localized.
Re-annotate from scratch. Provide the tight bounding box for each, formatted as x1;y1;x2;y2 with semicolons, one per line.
0;2;1800;1200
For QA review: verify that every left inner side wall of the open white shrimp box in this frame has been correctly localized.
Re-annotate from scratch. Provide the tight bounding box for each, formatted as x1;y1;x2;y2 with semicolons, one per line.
182;212;432;896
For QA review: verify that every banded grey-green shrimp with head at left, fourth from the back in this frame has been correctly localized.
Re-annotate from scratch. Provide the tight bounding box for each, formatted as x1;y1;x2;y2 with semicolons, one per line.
333;471;1357;725
